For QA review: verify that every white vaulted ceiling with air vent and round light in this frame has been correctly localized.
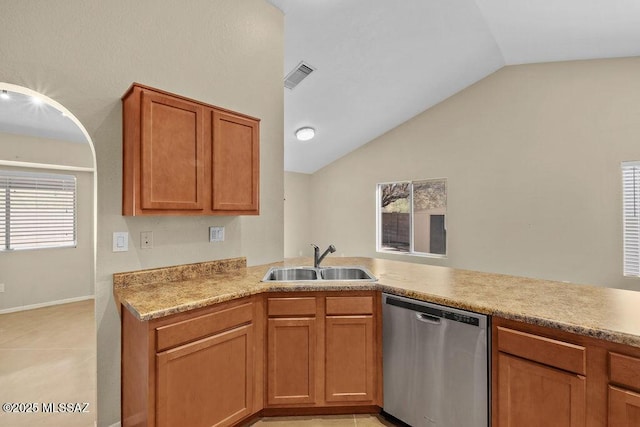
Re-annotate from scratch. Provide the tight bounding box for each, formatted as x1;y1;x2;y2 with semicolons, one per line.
268;0;640;173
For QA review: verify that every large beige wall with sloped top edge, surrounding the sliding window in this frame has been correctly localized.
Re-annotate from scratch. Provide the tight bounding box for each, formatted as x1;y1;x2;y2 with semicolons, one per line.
305;58;640;290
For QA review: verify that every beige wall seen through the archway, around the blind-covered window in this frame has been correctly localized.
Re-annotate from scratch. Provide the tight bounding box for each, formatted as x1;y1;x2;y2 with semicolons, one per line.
0;133;95;311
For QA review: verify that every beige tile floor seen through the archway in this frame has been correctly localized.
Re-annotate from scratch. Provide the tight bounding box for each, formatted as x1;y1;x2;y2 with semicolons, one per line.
0;300;96;427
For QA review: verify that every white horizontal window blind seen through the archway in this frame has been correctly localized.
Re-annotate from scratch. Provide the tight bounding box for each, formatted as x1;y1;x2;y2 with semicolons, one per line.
0;171;77;251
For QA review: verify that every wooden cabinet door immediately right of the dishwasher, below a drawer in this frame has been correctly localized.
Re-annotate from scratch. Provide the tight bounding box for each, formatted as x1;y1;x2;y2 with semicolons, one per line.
494;353;586;427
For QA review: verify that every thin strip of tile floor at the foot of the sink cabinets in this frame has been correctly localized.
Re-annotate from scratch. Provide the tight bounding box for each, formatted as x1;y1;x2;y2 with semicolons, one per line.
250;414;395;427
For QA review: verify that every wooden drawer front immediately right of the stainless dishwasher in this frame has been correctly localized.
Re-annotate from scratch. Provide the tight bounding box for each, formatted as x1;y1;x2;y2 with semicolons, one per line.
497;327;586;375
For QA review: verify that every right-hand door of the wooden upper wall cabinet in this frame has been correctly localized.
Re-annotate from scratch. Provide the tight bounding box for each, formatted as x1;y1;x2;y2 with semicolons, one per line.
211;110;260;214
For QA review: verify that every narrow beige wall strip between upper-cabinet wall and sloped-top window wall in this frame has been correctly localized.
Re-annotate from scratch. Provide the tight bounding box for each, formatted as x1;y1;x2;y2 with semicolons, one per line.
284;172;313;258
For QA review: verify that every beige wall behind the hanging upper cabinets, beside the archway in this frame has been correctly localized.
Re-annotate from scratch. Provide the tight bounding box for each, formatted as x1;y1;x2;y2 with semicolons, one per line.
0;0;284;426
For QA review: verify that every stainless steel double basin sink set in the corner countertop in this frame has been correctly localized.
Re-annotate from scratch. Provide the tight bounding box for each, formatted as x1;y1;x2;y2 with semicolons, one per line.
262;266;377;282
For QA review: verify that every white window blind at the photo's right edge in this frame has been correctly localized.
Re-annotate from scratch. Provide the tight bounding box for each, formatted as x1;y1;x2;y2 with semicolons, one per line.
622;162;640;277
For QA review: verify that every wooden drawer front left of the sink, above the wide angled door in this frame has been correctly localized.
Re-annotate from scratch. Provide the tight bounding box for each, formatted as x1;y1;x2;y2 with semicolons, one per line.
156;303;253;351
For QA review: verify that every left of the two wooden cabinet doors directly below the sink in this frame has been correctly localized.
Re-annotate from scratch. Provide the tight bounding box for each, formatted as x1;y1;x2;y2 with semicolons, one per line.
267;318;317;405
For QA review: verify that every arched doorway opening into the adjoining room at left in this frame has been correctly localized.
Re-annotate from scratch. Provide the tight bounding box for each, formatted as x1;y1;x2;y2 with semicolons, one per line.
0;82;97;426
